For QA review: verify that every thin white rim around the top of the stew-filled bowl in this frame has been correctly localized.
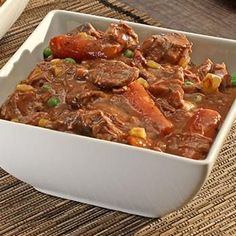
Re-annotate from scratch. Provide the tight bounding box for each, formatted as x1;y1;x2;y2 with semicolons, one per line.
0;10;236;165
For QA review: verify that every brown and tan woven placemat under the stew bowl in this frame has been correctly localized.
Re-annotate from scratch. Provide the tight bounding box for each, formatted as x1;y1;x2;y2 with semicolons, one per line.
0;0;236;236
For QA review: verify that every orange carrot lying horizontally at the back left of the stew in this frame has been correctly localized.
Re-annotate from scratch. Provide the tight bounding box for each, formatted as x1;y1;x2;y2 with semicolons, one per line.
49;35;123;61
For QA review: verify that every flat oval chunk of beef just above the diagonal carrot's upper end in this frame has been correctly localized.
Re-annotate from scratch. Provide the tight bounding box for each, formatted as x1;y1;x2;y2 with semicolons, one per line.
88;60;139;89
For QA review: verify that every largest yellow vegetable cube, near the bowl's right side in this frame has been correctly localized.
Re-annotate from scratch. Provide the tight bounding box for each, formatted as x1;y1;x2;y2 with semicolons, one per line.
202;73;222;93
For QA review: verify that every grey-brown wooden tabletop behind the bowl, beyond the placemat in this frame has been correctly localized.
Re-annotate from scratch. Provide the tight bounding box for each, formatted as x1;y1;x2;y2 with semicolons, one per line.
121;0;236;39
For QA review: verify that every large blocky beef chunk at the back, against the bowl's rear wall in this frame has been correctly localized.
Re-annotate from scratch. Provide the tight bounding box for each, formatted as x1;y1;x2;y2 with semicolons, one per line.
141;33;192;65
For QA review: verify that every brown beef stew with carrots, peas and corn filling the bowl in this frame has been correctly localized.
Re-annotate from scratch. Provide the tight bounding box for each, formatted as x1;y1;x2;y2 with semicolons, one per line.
0;22;236;159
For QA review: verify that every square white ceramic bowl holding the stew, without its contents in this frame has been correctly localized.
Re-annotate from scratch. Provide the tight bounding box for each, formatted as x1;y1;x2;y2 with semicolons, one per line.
0;11;236;217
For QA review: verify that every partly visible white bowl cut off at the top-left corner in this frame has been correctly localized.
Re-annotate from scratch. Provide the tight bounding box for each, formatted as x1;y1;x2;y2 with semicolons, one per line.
0;0;29;39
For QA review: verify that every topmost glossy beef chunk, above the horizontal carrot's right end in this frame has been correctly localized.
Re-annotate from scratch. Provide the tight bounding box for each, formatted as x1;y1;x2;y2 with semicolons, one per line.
105;23;139;48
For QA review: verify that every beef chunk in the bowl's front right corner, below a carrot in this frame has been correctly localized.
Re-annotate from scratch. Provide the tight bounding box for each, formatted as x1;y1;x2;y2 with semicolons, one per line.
166;133;212;160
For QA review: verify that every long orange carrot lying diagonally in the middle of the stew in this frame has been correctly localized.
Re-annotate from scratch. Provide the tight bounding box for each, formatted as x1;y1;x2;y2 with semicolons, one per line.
123;81;174;135
